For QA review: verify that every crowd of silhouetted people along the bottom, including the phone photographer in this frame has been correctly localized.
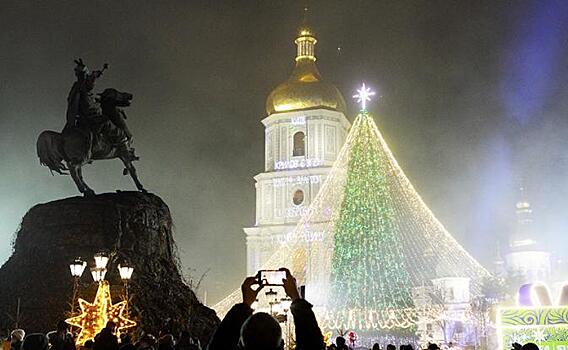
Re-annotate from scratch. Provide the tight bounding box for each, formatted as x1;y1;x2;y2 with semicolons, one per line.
2;268;539;350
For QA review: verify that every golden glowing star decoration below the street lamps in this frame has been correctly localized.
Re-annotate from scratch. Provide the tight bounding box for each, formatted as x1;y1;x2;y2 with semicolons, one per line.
65;280;136;345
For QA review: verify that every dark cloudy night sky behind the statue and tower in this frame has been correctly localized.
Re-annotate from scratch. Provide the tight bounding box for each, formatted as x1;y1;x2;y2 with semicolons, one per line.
0;0;568;301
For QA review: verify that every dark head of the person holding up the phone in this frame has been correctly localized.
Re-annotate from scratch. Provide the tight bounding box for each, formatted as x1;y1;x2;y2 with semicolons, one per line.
241;312;284;350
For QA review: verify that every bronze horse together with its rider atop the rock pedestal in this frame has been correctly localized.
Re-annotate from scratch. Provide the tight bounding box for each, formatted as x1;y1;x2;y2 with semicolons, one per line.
37;59;146;196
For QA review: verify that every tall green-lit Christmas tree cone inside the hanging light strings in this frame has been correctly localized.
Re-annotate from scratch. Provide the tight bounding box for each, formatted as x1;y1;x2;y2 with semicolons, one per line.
330;107;413;310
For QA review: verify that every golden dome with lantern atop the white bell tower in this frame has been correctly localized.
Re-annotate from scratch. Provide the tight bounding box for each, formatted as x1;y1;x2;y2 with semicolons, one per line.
266;27;345;115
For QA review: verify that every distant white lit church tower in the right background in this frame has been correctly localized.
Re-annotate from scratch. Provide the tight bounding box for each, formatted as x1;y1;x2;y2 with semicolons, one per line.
505;188;551;283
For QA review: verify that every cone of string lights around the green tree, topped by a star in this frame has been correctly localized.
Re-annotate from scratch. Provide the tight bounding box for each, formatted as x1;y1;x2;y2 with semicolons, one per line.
215;87;489;333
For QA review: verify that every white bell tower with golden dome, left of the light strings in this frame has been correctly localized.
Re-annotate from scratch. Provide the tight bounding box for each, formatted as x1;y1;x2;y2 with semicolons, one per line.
244;26;350;274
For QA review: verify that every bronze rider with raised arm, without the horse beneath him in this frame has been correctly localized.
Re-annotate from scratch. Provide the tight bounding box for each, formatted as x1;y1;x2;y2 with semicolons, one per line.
64;59;132;144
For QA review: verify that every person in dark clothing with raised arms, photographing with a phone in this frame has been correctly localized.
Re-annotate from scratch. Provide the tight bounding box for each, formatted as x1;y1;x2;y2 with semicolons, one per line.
207;268;325;350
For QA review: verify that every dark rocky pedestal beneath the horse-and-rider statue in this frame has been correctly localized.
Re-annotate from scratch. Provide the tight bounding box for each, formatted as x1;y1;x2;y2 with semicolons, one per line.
0;192;219;343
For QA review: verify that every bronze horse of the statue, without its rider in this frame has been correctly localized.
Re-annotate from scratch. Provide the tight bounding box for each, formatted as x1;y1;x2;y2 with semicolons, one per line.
37;89;146;196
